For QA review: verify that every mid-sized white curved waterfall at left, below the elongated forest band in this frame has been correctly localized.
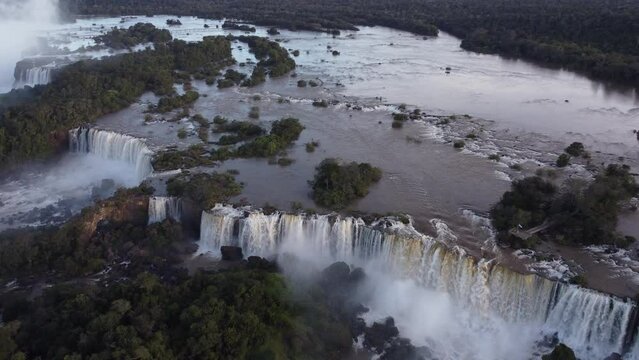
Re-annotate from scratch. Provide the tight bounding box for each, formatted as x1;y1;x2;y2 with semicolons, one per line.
69;128;153;181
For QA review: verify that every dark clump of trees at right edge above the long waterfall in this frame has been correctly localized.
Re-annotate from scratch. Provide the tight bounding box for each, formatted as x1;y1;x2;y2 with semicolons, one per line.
491;164;639;247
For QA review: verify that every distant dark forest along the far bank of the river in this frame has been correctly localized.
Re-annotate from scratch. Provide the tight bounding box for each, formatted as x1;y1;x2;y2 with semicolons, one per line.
63;0;639;85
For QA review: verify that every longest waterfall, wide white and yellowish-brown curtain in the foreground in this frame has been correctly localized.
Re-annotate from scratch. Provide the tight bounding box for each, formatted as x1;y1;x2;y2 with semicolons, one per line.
200;205;635;358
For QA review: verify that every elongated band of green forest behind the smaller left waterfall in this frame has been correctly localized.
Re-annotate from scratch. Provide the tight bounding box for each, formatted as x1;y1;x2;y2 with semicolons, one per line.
0;37;234;166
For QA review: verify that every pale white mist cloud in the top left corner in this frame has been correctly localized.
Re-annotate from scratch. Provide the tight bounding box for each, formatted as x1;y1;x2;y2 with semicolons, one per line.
0;0;58;92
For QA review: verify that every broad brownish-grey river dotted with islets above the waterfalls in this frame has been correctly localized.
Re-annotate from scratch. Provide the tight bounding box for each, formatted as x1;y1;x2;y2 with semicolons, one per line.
0;16;639;295
